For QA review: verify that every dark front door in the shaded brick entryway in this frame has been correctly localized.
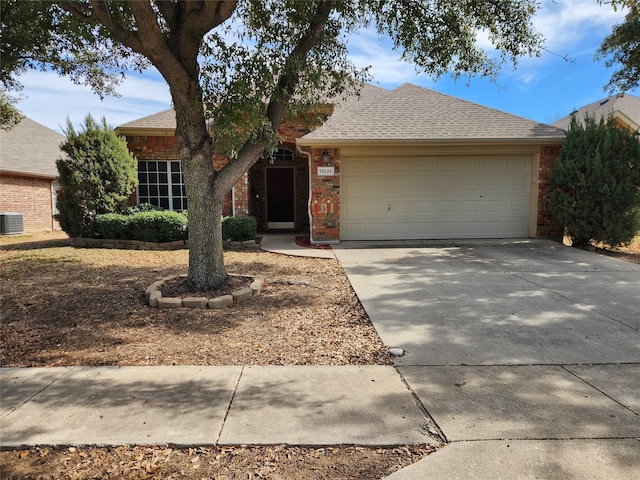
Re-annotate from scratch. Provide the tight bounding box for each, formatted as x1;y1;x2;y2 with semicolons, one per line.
267;167;295;230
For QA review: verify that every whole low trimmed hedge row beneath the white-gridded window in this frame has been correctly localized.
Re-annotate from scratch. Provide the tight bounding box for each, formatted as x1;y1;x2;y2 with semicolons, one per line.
94;211;187;243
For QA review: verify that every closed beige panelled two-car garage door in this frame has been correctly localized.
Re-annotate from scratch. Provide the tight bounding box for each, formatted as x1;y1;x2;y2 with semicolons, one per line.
340;155;532;240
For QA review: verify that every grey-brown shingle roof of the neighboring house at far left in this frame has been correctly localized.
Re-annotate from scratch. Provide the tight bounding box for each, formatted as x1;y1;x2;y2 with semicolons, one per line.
0;117;66;179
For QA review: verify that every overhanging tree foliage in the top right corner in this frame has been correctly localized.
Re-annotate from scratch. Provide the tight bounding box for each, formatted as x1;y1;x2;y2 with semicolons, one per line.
596;0;640;92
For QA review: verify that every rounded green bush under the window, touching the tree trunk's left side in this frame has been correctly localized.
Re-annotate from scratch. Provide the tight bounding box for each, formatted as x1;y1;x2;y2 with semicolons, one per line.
127;211;187;243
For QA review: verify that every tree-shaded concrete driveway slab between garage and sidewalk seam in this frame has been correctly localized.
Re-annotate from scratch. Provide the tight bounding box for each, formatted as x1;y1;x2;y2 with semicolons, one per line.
334;240;640;365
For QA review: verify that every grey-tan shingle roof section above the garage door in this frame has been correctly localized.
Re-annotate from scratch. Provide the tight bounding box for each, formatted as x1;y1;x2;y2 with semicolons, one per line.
299;83;565;146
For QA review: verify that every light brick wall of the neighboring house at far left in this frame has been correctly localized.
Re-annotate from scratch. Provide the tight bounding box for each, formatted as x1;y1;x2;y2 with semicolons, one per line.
0;174;55;232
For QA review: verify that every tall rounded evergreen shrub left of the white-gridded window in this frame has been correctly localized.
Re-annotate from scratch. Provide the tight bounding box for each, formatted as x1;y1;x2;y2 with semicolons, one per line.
56;115;137;237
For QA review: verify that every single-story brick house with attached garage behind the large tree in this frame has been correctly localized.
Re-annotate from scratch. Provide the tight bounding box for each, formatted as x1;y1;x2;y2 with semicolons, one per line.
118;84;565;243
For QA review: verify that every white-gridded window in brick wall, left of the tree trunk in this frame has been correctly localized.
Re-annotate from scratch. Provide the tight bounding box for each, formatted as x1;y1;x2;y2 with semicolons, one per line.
138;160;187;211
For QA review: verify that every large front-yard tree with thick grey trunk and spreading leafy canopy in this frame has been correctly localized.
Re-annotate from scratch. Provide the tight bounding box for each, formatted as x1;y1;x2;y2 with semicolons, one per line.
0;0;542;289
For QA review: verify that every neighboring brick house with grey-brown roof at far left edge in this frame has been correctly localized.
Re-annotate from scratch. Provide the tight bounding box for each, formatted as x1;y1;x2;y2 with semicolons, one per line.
0;117;65;232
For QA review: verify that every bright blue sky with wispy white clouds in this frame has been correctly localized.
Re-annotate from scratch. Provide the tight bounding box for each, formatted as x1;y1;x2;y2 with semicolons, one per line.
12;0;640;132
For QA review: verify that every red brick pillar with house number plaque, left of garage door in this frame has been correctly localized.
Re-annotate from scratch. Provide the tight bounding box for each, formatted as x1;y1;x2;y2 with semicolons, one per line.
311;148;340;242
